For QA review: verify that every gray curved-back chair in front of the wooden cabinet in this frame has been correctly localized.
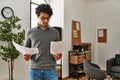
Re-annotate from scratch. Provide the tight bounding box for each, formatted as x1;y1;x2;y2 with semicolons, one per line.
83;60;106;80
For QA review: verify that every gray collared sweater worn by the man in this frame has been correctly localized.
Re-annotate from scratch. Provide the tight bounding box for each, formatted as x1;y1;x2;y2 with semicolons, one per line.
25;26;60;69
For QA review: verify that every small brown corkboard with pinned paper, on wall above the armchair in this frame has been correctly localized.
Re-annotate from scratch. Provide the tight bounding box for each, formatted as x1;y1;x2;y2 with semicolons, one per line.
98;29;107;43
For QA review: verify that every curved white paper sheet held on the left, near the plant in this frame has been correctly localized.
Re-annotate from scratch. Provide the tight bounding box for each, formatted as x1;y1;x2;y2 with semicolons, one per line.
13;42;39;55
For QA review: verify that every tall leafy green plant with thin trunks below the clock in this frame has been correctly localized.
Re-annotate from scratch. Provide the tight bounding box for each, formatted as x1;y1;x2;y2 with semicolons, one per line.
0;16;25;80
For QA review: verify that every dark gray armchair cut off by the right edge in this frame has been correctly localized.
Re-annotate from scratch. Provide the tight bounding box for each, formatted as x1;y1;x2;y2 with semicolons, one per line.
106;54;120;78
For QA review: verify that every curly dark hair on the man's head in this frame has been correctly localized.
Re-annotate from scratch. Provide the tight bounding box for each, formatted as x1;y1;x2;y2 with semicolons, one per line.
36;4;53;17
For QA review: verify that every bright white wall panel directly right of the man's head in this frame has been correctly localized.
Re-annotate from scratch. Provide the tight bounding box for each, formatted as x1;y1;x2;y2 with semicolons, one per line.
50;0;64;28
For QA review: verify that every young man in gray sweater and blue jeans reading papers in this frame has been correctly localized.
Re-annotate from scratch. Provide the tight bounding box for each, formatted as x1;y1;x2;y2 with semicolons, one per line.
24;4;61;80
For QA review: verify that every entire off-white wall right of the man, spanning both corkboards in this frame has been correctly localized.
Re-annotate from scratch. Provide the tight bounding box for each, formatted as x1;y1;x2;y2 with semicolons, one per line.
59;0;120;77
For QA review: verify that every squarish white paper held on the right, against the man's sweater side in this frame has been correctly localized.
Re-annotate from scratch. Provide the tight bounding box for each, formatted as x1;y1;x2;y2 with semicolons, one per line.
50;41;67;54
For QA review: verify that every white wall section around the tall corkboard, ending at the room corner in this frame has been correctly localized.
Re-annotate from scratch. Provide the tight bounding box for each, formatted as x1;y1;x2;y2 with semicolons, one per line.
62;0;95;77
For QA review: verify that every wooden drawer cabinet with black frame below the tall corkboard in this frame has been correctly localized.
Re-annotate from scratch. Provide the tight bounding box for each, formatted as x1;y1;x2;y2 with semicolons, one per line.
69;51;91;77
